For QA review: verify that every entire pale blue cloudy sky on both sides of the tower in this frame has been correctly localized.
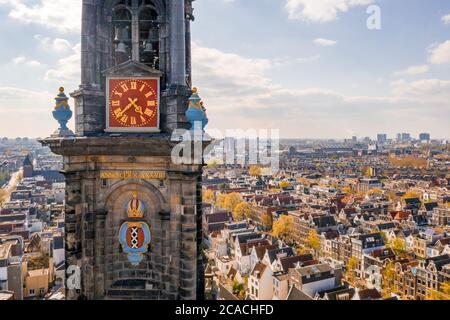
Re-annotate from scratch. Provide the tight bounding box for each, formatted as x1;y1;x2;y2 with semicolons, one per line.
0;0;450;138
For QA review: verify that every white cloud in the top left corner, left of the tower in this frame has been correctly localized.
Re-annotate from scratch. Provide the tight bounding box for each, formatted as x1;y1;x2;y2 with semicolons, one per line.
0;0;81;33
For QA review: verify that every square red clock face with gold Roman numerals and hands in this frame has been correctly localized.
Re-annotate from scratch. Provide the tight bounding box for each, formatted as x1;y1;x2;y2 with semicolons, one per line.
109;79;159;130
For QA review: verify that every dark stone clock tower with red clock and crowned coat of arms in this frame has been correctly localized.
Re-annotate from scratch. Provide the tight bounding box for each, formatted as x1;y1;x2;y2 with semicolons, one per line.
42;0;203;300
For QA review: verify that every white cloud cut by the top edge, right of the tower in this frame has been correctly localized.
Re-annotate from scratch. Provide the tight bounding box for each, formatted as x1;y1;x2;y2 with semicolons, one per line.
285;0;373;22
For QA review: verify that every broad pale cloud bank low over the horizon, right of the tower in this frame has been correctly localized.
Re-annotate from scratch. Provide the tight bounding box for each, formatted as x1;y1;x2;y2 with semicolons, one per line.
193;44;450;138
